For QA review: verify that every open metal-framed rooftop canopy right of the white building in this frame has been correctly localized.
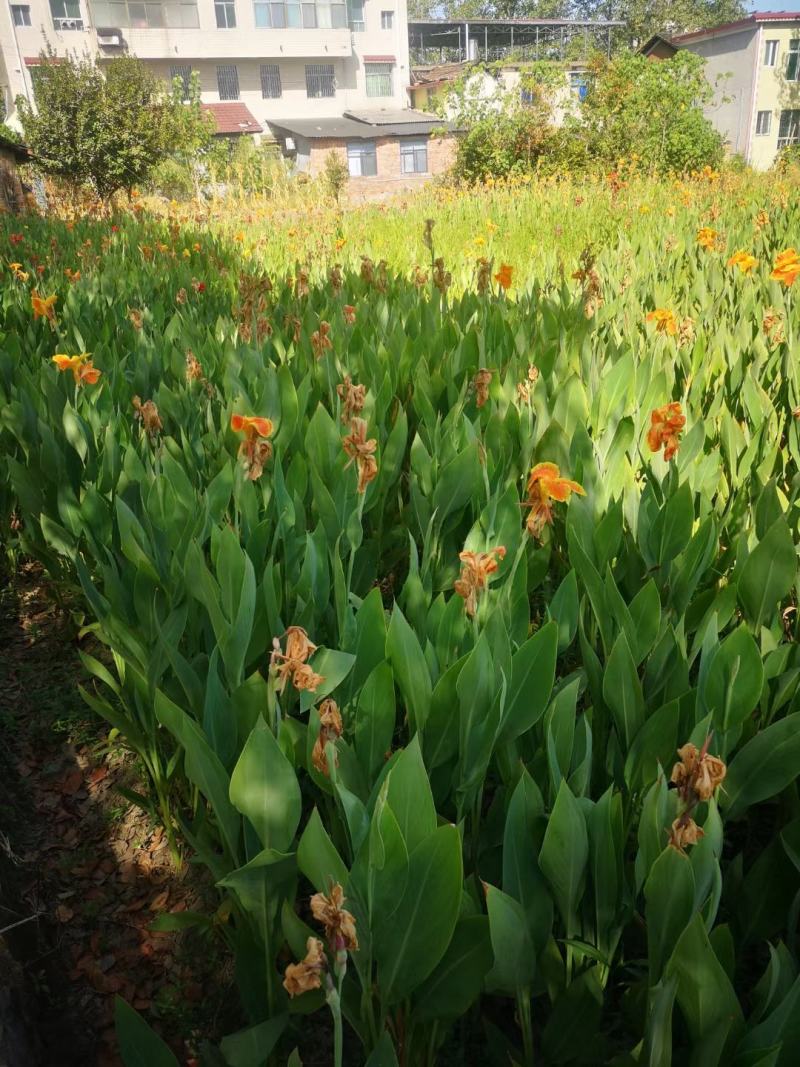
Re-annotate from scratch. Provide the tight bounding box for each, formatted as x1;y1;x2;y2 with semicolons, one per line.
409;18;625;65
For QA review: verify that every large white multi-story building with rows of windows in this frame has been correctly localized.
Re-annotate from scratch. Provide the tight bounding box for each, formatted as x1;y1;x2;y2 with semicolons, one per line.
0;0;460;177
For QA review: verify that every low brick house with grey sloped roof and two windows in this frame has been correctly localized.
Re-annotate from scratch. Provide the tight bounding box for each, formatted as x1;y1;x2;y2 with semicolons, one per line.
270;109;455;188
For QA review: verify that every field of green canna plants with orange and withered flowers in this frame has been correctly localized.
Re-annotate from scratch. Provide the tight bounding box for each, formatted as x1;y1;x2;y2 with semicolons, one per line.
0;169;800;1067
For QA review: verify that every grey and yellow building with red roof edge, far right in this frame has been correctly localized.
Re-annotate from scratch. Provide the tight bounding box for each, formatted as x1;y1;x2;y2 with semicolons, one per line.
671;11;800;170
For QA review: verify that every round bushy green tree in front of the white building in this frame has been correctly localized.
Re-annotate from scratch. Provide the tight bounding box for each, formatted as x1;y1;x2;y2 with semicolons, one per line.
17;52;188;200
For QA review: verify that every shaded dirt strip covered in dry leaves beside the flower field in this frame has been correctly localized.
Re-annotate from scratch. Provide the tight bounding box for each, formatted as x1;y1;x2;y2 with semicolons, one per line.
0;568;235;1067
